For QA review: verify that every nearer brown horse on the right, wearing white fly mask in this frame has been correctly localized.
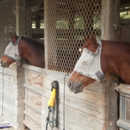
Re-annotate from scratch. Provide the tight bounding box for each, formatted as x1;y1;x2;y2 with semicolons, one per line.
68;35;130;93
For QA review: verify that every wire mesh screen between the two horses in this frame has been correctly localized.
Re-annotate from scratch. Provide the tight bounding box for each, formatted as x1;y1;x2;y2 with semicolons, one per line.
45;0;102;72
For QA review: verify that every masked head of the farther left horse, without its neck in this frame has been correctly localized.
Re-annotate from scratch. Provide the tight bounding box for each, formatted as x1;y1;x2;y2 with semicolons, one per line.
1;33;20;67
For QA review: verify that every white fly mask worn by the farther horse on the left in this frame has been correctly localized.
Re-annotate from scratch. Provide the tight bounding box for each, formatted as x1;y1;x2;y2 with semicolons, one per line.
4;37;21;61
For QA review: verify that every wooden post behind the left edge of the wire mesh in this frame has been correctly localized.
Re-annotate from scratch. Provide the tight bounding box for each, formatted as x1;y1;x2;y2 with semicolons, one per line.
44;0;57;69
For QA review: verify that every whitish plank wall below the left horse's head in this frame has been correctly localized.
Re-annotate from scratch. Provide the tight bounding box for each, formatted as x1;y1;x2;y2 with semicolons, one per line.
0;63;24;130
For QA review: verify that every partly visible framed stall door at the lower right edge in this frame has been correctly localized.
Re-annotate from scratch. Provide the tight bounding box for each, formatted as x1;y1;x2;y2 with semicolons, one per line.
115;84;130;130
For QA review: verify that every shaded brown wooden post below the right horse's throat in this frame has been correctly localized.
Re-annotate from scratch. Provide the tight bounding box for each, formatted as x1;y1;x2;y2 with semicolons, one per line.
101;74;119;130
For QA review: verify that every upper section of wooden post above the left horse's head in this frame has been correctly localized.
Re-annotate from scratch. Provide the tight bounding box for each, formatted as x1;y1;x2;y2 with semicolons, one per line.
16;0;25;35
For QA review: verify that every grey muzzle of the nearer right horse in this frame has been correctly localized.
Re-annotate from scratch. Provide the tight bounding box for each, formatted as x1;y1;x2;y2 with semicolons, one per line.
68;81;83;94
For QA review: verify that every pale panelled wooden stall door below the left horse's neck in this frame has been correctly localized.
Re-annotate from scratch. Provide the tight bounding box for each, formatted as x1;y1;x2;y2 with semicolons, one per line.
23;65;43;130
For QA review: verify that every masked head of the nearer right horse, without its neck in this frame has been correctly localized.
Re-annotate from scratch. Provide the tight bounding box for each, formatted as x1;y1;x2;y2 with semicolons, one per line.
68;35;102;93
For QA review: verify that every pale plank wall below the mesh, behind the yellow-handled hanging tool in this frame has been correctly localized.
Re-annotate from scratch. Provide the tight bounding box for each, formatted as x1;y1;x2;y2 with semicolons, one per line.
42;69;117;130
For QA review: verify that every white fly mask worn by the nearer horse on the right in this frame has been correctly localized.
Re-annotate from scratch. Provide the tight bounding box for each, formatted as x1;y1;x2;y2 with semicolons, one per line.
74;40;104;80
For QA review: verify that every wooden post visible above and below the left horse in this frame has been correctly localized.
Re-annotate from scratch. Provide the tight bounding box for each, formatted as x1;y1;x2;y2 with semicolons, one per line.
16;0;26;130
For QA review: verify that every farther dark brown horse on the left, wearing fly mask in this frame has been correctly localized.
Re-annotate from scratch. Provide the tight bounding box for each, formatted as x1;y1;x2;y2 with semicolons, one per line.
1;33;45;68
